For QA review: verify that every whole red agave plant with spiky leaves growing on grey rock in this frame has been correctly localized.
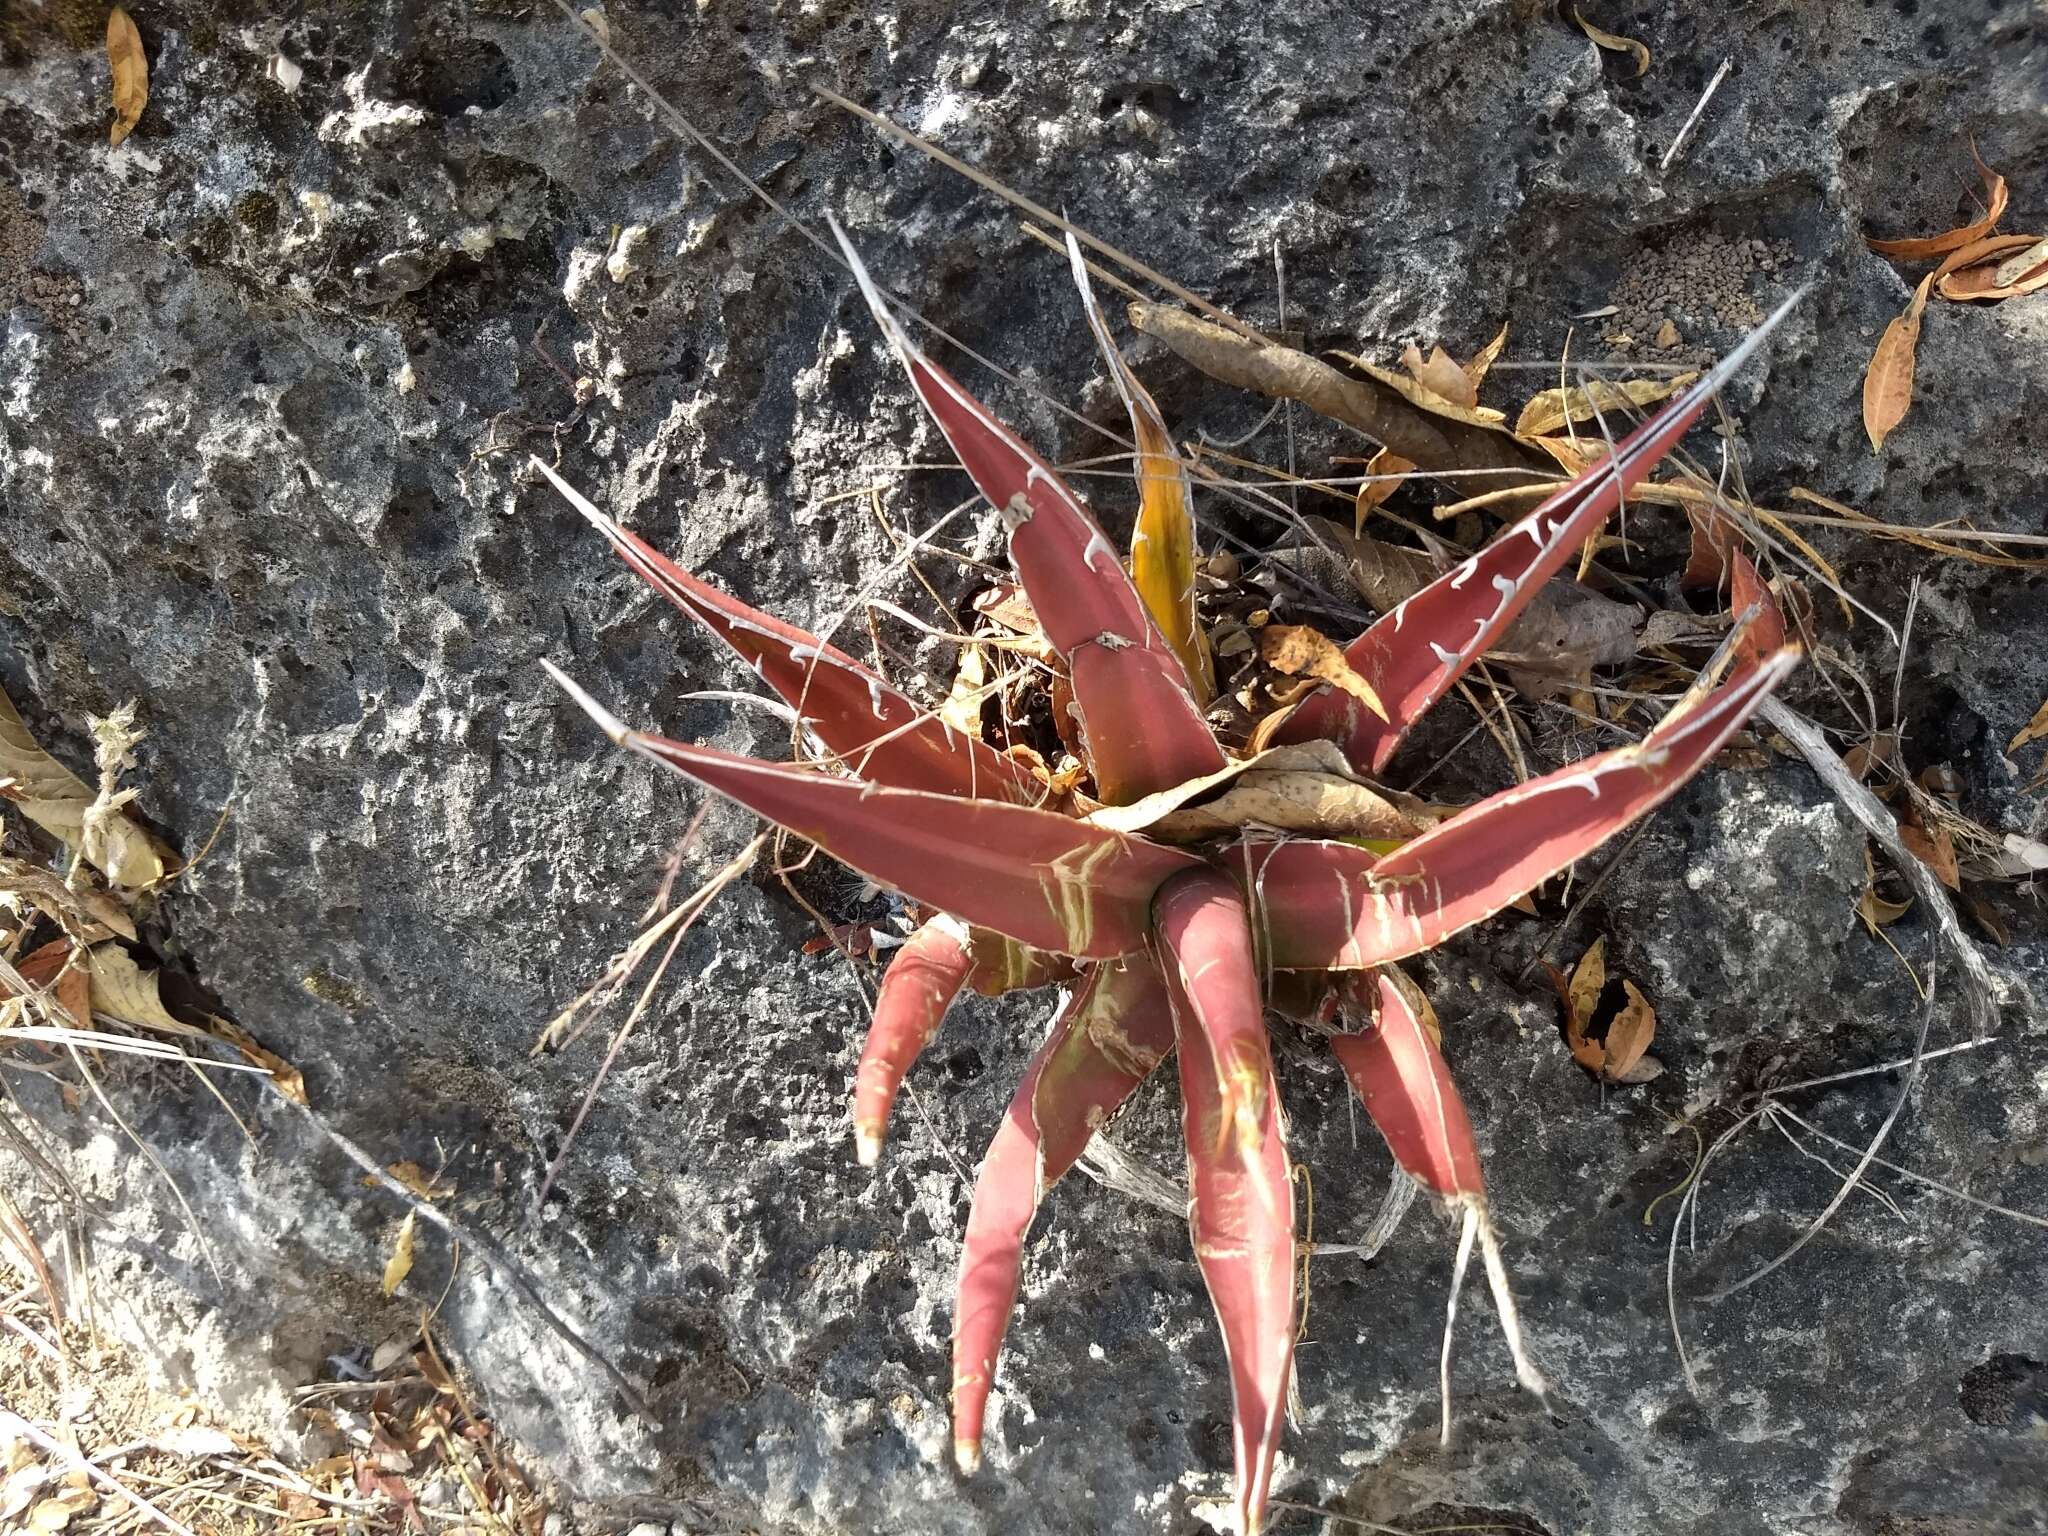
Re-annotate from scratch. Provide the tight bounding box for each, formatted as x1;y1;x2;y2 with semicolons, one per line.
541;236;1798;1532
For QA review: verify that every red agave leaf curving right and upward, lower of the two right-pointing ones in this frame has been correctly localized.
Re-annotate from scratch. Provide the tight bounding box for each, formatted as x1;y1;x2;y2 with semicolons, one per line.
1229;647;1798;971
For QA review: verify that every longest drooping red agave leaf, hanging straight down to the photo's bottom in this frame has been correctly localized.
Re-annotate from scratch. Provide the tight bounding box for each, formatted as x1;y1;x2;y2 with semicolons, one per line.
1155;870;1294;1532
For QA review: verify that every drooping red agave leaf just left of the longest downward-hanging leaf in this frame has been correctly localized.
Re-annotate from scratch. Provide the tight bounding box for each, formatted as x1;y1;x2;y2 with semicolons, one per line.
952;954;1174;1473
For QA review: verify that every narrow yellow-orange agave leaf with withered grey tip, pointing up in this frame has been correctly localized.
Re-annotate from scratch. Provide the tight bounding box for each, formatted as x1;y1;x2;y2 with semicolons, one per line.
1067;236;1217;707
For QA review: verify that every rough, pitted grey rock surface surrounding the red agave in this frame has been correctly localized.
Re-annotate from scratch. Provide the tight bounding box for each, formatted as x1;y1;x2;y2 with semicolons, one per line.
0;0;2048;1536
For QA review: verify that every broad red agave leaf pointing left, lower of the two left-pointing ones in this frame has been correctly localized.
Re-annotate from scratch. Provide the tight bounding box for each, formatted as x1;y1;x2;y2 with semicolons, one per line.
543;662;1202;961
